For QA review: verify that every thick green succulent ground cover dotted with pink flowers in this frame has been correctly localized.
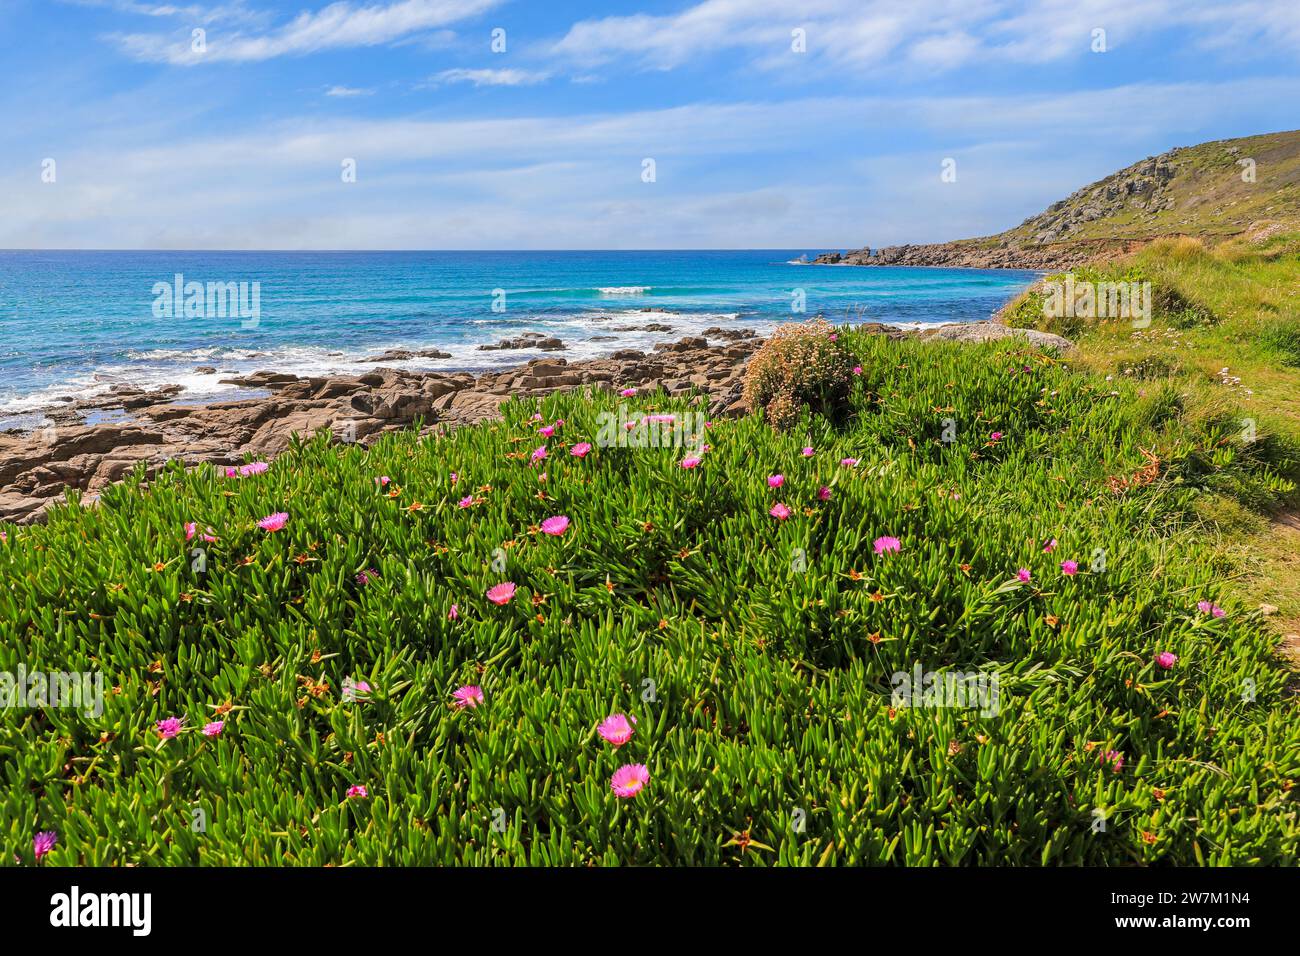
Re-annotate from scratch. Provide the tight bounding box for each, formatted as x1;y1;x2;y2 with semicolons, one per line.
0;333;1300;865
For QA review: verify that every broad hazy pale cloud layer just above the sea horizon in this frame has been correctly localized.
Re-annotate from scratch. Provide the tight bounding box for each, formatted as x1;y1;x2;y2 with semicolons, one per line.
0;79;1300;248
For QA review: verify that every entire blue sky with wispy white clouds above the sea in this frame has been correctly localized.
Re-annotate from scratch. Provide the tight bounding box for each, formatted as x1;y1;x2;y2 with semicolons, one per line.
0;0;1300;248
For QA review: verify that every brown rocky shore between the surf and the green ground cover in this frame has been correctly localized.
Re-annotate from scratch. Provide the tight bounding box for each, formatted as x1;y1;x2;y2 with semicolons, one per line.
0;323;1070;523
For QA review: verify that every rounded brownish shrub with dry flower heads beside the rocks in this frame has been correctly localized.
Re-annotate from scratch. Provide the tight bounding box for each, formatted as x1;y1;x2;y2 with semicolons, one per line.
744;319;857;431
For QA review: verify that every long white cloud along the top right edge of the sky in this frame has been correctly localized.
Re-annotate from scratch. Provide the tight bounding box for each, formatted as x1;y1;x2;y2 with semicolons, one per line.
550;0;1300;72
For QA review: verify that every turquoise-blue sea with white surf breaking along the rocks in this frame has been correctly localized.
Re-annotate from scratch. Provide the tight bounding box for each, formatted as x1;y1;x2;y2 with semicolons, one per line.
0;248;1037;427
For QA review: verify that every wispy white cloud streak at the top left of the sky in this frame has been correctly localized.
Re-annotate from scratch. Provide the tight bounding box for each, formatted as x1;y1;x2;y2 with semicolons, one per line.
113;0;502;66
